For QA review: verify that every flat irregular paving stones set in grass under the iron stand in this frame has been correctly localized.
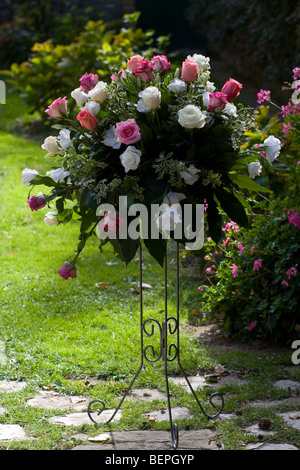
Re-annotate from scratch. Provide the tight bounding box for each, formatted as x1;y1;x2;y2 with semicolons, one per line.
0;374;300;450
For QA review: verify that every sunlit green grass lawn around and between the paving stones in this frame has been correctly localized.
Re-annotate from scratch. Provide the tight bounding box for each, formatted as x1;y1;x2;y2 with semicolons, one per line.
0;85;300;450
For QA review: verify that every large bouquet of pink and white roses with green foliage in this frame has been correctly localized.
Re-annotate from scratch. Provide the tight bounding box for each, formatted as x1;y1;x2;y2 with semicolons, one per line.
22;54;280;278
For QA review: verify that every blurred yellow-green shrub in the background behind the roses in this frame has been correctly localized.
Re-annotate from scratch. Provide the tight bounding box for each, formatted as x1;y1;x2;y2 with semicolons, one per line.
10;13;168;117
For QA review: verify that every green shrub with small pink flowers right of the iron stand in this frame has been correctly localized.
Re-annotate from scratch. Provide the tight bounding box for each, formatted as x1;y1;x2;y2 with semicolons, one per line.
199;68;300;343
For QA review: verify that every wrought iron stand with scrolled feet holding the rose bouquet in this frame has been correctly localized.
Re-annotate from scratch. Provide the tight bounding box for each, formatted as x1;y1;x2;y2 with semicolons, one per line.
88;243;224;449
